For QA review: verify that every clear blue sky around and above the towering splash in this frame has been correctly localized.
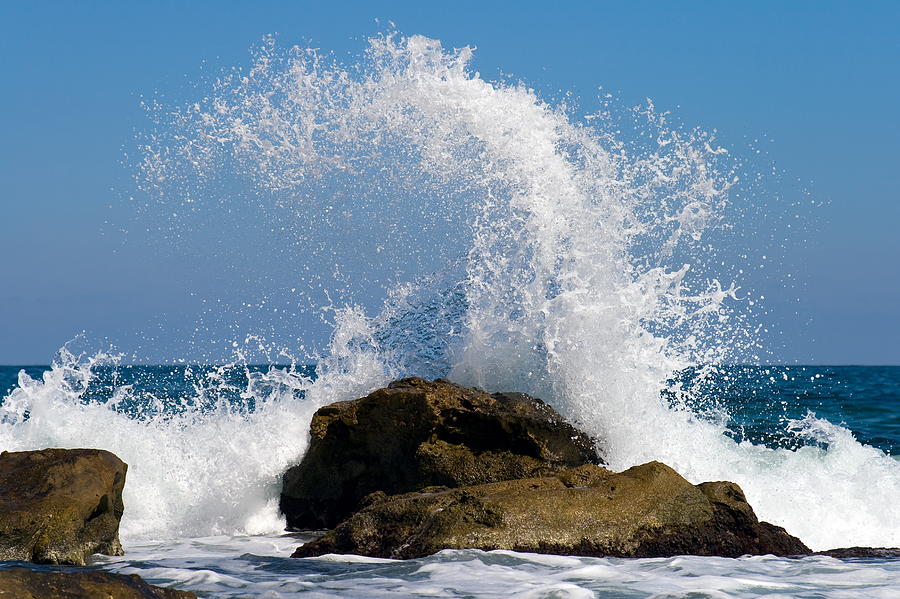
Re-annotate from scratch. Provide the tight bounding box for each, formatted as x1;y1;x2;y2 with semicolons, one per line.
0;0;900;364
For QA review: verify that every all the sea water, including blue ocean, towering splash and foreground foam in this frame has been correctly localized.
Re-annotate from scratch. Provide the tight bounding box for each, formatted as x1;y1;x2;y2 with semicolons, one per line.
0;33;900;597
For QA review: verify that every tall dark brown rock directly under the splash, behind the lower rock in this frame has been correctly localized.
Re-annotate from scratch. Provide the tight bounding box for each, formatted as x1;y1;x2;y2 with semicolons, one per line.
281;378;597;529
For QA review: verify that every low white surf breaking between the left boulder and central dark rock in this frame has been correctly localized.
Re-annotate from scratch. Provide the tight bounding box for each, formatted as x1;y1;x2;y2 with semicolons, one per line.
0;313;390;545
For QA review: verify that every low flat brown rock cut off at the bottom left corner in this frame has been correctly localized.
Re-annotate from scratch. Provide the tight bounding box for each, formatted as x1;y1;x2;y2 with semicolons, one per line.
0;568;197;599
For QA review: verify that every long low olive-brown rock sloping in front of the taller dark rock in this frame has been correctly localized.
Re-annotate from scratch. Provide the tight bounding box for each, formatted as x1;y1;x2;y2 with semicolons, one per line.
294;462;809;559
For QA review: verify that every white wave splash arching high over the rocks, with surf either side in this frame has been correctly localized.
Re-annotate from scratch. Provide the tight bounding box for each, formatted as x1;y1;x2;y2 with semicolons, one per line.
0;35;900;548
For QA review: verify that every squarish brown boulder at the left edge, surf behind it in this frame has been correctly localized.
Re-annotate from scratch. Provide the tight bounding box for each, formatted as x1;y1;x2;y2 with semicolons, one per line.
0;449;128;565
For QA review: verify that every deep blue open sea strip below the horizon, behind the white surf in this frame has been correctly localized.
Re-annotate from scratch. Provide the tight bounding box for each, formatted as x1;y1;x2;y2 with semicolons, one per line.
0;365;900;459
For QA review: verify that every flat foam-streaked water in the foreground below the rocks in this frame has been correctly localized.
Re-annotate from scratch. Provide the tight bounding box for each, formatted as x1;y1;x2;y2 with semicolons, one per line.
98;537;900;599
